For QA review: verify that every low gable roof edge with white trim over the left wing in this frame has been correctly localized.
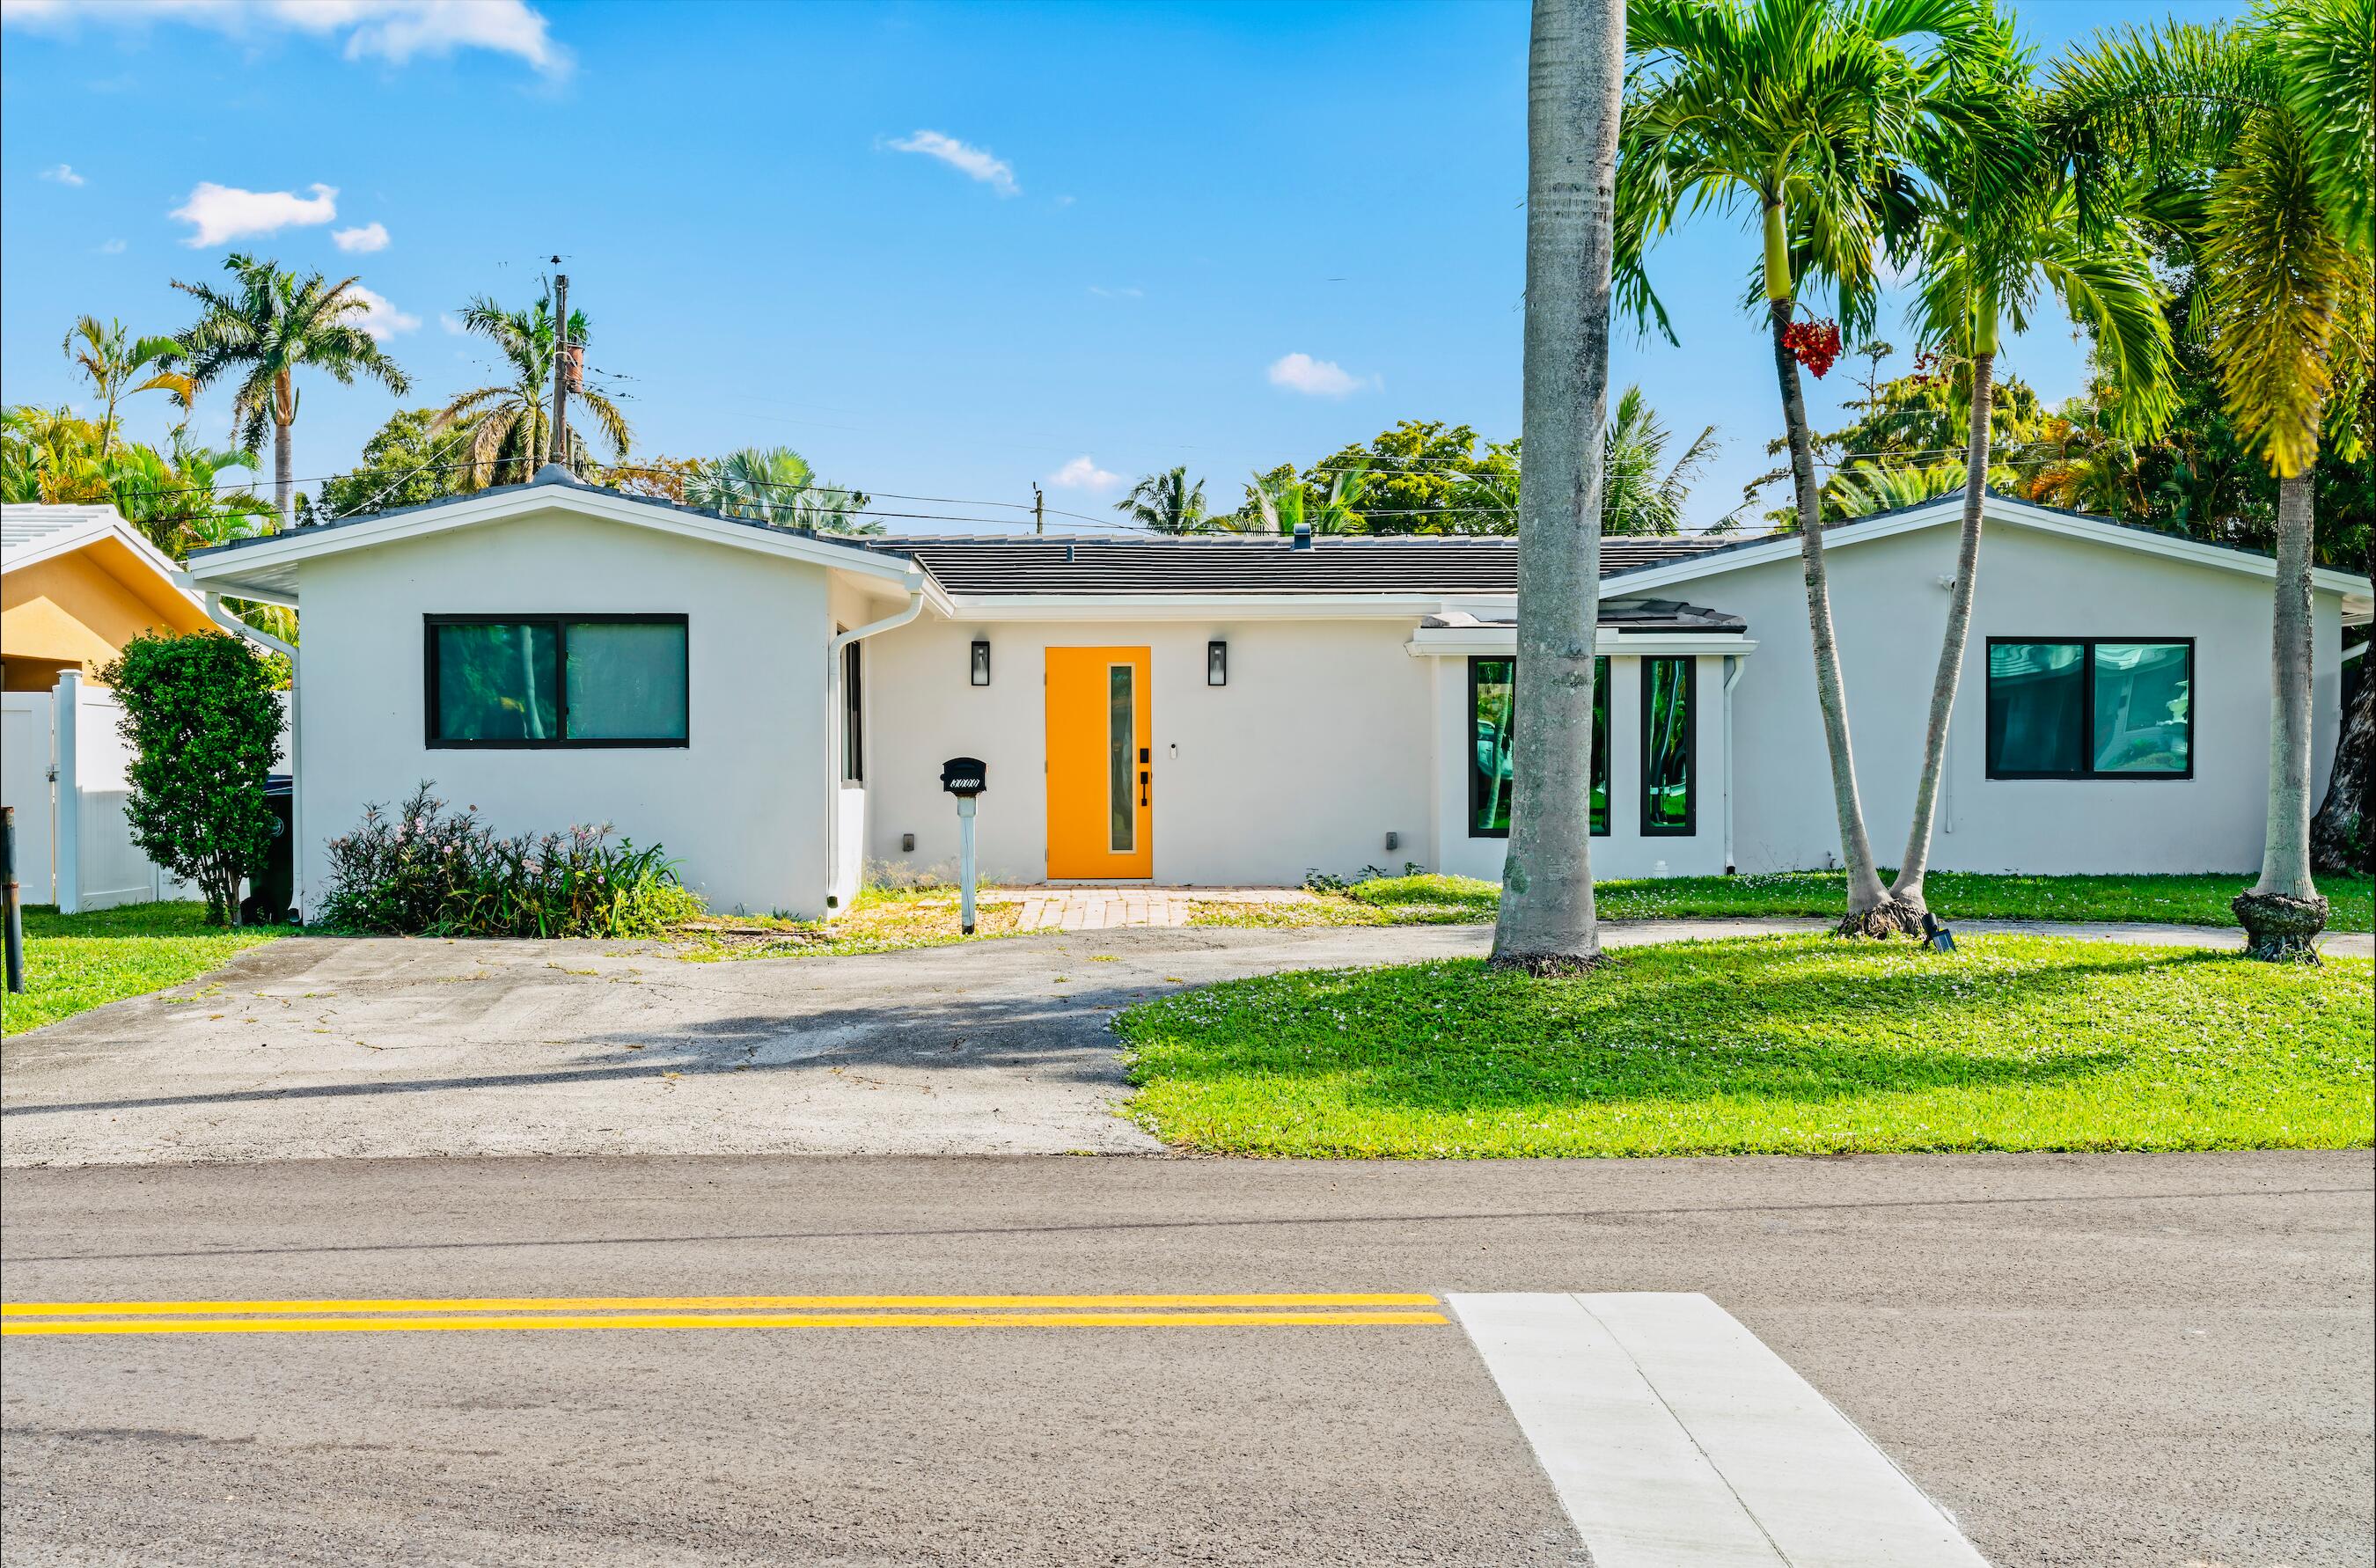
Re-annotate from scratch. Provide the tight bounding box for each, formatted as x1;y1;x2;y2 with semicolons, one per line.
187;464;931;604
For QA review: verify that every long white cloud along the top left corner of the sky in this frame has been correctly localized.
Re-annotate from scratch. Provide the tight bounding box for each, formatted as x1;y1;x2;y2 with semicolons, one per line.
0;0;570;76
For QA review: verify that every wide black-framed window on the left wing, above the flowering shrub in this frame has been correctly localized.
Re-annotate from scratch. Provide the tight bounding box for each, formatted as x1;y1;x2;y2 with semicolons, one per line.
423;615;692;749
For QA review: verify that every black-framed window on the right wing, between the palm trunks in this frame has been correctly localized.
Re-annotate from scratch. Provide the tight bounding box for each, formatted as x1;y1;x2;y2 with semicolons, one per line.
1989;637;2196;780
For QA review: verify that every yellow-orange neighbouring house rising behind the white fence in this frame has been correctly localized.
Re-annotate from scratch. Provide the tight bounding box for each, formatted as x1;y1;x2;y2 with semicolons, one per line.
0;506;216;692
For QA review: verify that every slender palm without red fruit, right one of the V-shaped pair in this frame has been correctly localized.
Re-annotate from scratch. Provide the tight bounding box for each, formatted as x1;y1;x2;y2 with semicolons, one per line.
1889;21;2172;912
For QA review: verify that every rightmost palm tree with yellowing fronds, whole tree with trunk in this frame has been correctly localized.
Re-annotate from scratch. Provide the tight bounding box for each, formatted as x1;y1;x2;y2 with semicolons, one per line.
2057;0;2376;960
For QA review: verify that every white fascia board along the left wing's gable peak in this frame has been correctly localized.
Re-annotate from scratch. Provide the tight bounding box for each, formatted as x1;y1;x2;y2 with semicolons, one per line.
173;485;924;598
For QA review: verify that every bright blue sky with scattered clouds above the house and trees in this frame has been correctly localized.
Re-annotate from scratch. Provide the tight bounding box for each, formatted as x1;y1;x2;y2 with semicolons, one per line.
0;0;2240;527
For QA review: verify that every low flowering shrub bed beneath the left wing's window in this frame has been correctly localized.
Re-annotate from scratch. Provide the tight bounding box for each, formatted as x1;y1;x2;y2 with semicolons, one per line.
323;784;701;936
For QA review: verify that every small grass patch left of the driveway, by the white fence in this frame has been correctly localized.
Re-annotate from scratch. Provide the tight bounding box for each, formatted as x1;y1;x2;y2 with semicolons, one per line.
0;903;295;1034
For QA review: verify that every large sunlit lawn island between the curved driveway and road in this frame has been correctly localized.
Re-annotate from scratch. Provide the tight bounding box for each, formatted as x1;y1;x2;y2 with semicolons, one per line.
1114;936;2376;1160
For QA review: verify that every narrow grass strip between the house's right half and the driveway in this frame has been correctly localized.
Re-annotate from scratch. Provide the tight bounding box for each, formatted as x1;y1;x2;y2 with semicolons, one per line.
1198;872;2376;931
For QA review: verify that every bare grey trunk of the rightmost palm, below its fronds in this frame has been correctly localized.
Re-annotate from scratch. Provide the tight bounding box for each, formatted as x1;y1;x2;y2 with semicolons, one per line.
2233;464;2326;963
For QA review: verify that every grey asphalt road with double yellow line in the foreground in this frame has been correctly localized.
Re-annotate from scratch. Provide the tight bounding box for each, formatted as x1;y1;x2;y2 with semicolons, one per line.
0;1153;2376;1568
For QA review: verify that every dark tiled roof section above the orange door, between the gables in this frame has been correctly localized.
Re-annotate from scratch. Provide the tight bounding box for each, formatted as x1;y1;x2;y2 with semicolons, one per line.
865;535;1725;597
